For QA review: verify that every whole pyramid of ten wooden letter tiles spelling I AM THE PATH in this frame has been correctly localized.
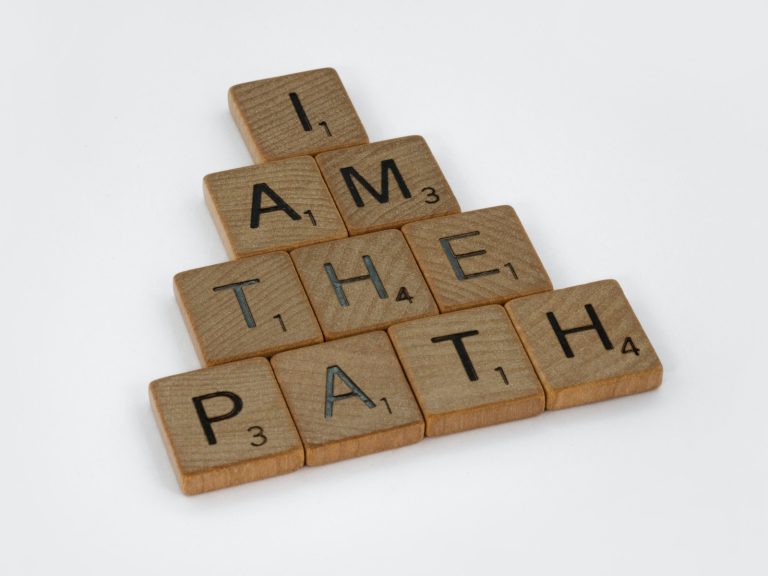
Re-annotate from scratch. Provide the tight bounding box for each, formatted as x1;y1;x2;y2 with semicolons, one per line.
150;68;662;494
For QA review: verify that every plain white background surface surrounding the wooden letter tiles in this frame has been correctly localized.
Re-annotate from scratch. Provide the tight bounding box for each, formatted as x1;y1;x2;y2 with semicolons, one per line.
0;0;768;576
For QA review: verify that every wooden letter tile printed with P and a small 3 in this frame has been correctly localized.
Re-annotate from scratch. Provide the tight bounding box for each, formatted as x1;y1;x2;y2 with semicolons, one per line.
149;358;304;494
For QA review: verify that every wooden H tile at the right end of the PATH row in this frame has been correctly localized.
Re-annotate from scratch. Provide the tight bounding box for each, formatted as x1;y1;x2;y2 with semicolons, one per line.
506;280;662;410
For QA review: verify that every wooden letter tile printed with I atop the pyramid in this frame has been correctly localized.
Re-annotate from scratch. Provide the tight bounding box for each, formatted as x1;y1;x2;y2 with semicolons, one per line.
229;68;368;164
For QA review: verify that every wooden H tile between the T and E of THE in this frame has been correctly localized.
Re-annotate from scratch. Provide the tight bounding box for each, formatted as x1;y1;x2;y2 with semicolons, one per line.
291;230;438;339
